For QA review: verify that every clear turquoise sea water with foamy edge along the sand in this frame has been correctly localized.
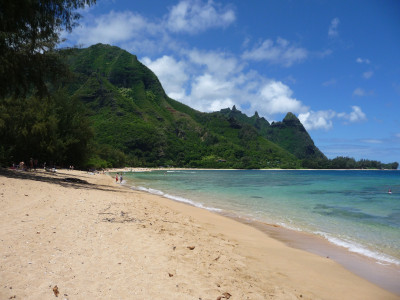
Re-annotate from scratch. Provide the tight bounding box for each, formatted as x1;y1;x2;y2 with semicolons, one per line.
124;170;400;265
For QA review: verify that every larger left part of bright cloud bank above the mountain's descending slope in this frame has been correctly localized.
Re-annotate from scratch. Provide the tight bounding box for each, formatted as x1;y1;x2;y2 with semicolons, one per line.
143;50;244;112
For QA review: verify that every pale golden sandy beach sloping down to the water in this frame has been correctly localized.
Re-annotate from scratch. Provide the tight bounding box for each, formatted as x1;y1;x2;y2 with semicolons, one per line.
0;169;399;300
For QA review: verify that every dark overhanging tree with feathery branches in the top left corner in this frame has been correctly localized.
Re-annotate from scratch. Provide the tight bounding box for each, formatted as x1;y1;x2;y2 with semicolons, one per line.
0;0;96;99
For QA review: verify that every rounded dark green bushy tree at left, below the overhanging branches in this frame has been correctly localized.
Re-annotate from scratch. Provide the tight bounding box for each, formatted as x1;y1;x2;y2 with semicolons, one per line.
0;91;93;166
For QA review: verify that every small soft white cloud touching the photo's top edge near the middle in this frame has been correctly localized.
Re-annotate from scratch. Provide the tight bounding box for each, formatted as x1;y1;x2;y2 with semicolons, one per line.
166;0;236;34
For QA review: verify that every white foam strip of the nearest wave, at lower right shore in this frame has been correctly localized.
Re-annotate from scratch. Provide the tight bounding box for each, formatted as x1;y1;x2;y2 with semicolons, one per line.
314;231;400;265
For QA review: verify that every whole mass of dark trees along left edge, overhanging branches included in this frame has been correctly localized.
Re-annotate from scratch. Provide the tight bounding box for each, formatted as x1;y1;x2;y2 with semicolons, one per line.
0;0;95;165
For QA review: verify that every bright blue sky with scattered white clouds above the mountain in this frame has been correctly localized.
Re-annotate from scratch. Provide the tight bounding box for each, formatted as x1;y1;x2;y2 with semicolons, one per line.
60;0;400;163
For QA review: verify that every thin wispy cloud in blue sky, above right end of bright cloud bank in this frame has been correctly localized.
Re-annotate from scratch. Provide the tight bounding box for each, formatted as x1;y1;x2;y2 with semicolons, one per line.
242;38;308;67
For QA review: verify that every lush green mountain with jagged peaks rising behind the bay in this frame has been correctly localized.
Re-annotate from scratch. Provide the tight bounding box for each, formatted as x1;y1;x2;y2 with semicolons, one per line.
61;44;325;168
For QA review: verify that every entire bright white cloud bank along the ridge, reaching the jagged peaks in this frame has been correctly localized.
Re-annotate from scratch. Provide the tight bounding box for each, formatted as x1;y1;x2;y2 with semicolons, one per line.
143;49;308;118
